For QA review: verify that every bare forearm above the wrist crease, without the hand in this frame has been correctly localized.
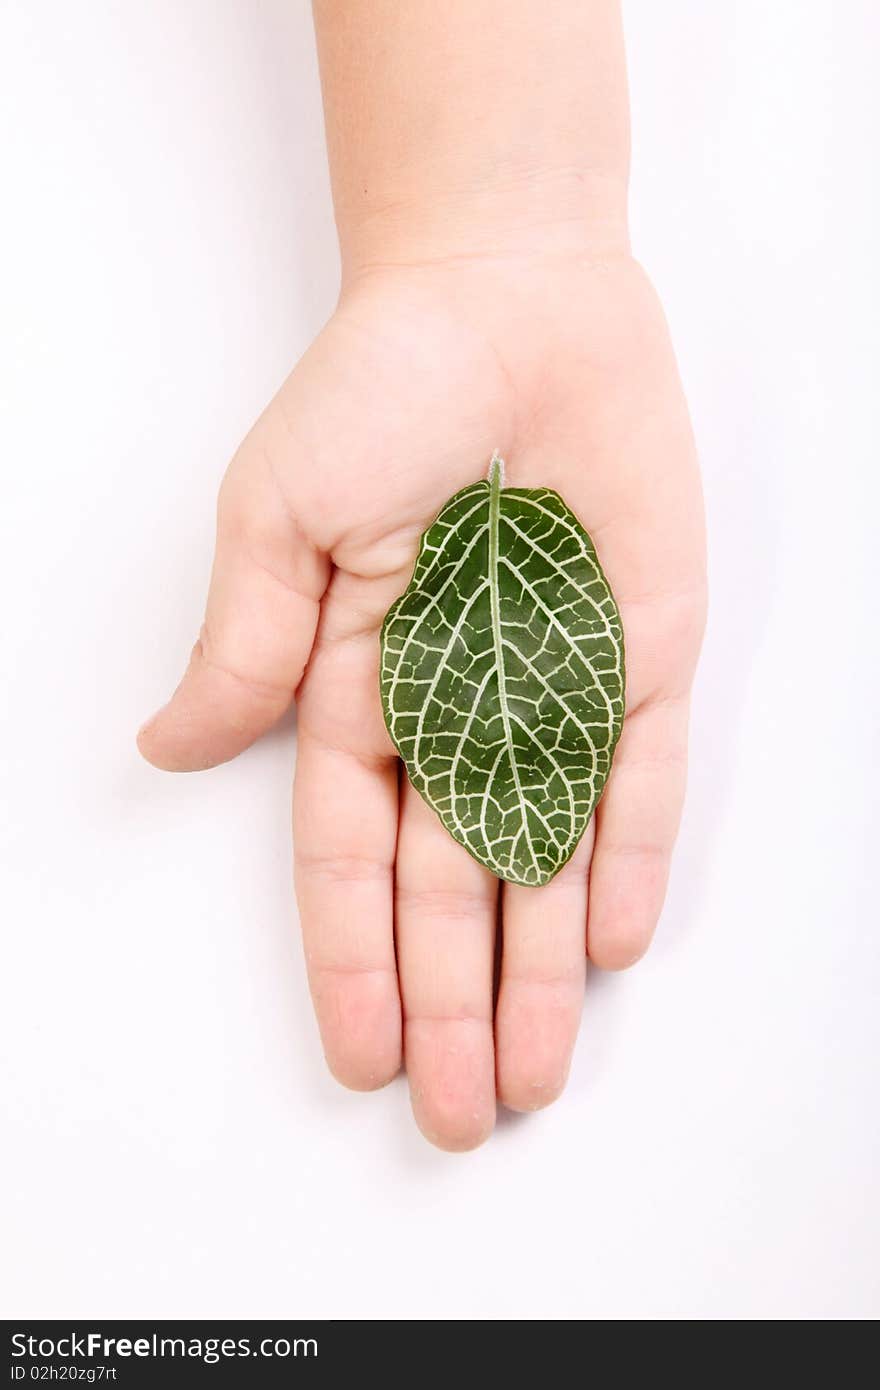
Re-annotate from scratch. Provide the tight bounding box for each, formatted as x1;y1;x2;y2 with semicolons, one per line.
314;0;628;275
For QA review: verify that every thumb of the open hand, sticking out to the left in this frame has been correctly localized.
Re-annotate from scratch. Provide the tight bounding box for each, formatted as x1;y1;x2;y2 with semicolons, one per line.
138;436;329;771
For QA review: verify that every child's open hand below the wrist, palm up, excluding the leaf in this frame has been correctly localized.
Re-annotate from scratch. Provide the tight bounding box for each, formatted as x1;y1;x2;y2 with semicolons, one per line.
140;254;705;1148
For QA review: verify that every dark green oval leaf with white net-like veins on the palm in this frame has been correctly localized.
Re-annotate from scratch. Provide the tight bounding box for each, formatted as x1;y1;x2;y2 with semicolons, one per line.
381;456;624;884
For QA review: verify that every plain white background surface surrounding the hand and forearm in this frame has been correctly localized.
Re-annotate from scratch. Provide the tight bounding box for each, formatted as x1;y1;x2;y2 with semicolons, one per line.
0;0;880;1319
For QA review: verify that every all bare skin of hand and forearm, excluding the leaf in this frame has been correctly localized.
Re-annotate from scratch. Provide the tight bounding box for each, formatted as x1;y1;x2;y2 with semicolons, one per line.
139;0;705;1150
